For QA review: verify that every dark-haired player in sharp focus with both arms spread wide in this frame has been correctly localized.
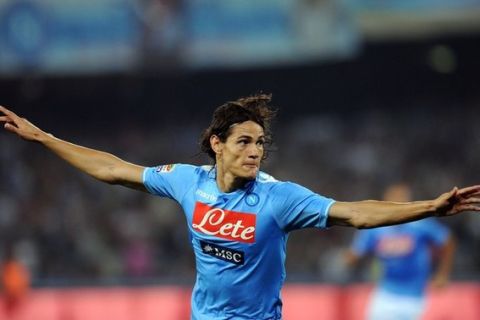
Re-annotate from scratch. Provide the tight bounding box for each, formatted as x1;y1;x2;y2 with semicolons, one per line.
0;94;480;320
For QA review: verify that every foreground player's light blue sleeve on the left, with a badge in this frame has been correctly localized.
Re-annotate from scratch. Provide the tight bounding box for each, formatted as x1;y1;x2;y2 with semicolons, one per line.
143;164;197;202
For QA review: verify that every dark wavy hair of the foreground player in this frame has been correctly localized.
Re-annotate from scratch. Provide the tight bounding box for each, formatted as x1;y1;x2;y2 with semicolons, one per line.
200;93;276;162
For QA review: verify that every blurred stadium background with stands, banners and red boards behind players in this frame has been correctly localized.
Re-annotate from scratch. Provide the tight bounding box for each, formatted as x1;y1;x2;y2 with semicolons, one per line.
0;0;480;320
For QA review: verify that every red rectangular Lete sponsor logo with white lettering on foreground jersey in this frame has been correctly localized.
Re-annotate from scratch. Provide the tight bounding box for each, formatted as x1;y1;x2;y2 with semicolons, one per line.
192;202;257;243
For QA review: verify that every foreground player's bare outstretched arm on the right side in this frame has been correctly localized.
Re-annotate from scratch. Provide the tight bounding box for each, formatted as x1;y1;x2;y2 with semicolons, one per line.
328;185;480;229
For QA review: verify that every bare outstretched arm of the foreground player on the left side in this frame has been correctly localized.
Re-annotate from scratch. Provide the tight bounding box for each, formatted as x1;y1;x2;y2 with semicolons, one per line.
0;106;146;191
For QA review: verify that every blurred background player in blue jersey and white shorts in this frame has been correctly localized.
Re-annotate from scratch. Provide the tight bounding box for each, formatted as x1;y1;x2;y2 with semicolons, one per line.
347;184;455;320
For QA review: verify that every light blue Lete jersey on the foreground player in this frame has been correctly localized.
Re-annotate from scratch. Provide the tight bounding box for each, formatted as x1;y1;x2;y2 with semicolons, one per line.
143;164;334;320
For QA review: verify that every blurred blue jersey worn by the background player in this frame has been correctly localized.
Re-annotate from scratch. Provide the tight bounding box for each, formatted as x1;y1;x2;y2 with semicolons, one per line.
352;218;449;297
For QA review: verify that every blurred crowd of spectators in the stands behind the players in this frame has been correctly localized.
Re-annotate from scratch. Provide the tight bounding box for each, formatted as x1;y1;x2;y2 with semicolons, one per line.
0;96;480;286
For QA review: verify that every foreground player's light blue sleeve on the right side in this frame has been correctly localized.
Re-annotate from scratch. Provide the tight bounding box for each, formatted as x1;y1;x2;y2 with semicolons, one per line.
273;182;335;232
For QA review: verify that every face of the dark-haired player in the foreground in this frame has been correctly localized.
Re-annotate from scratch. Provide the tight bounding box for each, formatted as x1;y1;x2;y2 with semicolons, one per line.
217;121;265;180
